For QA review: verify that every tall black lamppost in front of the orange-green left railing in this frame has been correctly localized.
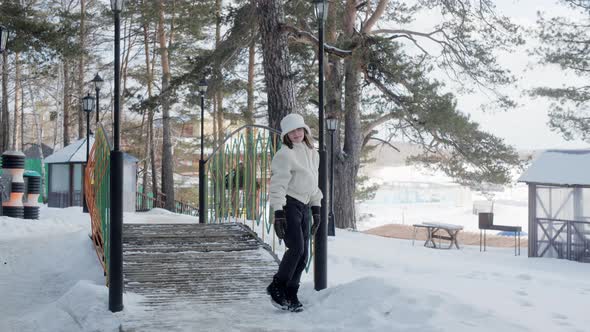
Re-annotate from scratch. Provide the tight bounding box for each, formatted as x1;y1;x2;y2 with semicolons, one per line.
109;0;124;312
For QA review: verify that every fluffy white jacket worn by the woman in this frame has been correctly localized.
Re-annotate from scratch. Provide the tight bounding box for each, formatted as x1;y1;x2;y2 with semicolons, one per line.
269;143;323;211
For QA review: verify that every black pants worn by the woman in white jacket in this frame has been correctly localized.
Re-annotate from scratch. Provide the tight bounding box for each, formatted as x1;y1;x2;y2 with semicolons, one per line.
276;196;310;287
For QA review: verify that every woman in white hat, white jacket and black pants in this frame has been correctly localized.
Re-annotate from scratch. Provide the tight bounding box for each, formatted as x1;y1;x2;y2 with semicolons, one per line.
266;113;323;312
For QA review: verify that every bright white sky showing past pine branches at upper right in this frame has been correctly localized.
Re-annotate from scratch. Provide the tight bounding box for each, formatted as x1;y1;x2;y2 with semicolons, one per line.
414;0;590;150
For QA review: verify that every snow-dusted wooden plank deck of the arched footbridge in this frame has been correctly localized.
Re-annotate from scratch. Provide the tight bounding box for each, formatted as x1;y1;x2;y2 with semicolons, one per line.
122;223;279;331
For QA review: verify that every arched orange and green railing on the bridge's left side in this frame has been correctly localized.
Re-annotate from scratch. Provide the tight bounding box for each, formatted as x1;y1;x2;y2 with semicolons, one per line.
84;126;111;285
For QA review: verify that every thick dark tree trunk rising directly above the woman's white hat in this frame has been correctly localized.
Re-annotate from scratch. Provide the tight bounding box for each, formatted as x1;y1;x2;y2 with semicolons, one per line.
257;0;295;129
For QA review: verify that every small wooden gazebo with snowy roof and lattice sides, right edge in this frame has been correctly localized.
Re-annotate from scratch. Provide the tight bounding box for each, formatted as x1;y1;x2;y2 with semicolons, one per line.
518;149;590;262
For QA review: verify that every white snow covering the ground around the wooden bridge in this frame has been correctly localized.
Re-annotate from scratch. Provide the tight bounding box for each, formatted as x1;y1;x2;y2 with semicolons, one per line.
0;165;590;332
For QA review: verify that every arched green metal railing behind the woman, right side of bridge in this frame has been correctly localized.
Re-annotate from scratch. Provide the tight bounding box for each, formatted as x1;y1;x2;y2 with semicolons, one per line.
205;125;313;269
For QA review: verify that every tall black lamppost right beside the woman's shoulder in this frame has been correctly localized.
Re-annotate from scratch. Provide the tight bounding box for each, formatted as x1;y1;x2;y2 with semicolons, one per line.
313;0;328;291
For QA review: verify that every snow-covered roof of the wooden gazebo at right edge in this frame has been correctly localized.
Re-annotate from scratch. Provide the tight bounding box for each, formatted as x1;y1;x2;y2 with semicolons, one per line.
518;149;590;186
